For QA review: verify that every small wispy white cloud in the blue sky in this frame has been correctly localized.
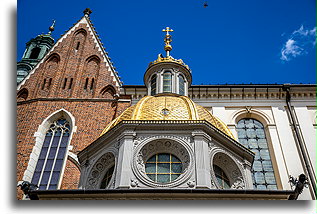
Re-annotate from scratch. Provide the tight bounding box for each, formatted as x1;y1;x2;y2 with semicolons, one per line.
280;25;316;61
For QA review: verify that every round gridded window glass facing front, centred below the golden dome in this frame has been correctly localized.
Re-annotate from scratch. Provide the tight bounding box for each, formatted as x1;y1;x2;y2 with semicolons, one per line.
145;153;183;183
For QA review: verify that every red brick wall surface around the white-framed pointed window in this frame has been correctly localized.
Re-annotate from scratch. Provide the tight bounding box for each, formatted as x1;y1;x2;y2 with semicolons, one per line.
17;17;130;199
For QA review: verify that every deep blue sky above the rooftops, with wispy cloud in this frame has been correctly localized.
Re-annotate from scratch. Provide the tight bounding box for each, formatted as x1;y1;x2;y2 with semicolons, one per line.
17;0;316;85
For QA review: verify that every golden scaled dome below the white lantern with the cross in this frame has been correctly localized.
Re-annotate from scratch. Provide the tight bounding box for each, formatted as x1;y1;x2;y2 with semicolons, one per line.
101;94;235;139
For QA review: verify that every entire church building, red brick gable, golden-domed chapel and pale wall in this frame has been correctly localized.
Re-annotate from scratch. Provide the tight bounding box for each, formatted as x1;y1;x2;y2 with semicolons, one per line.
17;9;317;200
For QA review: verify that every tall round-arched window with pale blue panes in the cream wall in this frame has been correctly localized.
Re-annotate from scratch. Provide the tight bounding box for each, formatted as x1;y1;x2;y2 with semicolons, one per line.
237;118;277;189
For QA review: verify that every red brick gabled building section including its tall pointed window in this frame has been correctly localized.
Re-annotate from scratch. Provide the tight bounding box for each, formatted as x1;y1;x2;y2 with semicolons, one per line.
17;9;131;199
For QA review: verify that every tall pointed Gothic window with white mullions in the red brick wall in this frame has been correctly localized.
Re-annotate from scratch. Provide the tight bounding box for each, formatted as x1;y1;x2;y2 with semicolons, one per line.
32;117;71;190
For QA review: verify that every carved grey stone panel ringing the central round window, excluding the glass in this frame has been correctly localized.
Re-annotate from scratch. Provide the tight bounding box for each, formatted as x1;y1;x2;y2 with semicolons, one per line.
132;136;195;187
